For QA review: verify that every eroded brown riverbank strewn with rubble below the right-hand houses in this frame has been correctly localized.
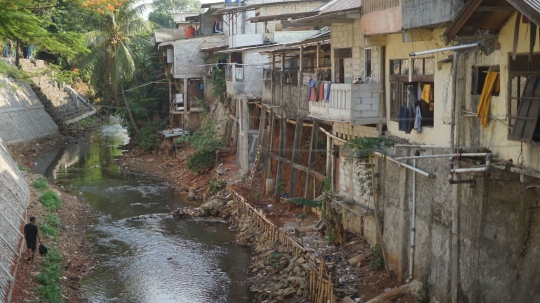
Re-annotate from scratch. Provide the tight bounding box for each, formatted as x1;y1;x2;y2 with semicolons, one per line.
170;186;419;302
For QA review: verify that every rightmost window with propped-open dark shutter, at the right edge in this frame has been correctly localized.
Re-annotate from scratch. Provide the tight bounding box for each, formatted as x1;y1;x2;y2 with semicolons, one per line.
507;54;540;145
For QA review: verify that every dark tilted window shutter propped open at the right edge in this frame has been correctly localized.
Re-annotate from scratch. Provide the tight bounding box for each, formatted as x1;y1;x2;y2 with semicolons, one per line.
510;76;540;143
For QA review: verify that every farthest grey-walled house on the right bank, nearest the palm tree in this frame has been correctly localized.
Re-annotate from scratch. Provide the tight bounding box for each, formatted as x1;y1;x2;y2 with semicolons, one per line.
155;3;227;129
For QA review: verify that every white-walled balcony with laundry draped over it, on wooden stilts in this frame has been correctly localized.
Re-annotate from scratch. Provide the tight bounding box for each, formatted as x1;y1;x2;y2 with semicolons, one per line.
309;82;384;125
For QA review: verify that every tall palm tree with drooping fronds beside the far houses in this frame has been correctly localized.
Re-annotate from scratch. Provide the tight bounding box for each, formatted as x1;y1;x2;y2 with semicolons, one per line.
81;1;155;136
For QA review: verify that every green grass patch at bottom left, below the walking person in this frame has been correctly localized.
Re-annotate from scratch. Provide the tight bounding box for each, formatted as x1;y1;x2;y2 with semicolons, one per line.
37;250;64;303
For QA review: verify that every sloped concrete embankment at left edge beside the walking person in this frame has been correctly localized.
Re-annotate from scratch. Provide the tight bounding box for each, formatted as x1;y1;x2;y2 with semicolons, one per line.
0;139;30;303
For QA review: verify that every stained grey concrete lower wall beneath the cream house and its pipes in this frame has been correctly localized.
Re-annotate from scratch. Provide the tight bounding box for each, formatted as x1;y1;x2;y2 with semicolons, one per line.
381;149;540;302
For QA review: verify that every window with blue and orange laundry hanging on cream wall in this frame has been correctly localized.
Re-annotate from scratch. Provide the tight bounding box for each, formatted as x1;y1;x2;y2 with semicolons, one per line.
389;58;435;127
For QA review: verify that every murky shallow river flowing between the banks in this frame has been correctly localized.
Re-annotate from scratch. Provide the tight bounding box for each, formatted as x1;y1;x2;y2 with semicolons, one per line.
36;121;251;303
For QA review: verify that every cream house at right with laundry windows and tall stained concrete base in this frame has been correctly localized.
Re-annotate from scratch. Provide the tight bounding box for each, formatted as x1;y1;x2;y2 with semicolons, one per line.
361;0;540;302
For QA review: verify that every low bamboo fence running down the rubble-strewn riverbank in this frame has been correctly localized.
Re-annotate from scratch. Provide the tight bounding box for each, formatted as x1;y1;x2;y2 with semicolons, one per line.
227;186;337;303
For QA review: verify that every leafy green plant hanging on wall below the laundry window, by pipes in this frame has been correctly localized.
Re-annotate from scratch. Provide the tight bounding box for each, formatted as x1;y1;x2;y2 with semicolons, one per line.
345;137;395;196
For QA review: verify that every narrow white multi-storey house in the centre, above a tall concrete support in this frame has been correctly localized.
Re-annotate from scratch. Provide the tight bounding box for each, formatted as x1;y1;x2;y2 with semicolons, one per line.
213;0;325;174
